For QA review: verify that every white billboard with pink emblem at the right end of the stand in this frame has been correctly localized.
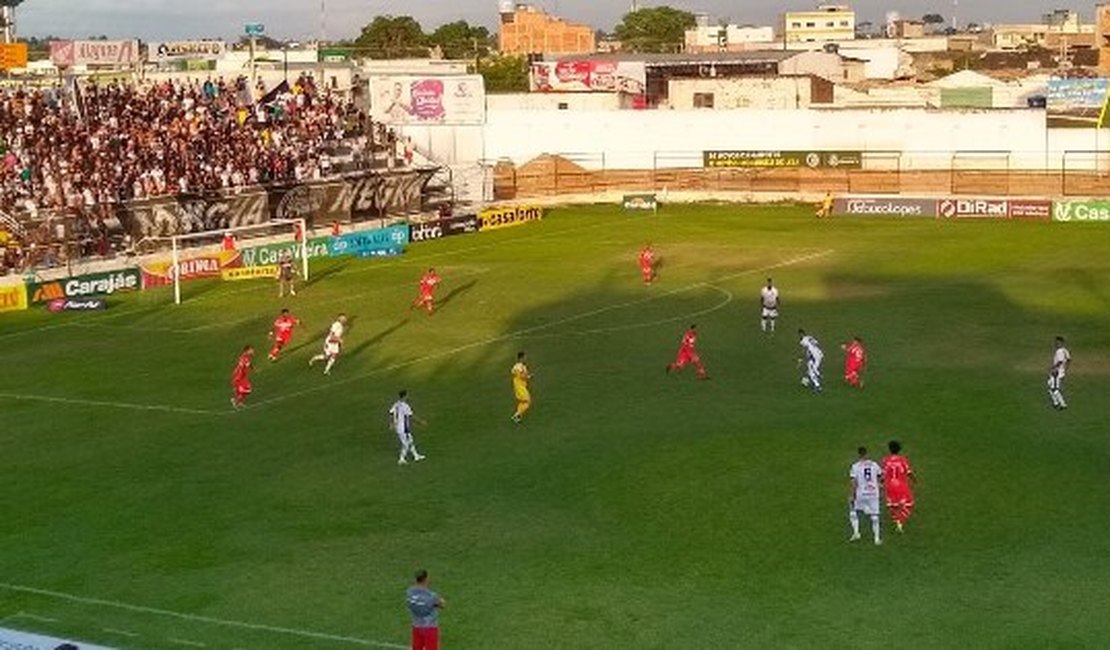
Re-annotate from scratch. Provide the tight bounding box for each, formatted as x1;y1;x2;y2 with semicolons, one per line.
370;74;485;125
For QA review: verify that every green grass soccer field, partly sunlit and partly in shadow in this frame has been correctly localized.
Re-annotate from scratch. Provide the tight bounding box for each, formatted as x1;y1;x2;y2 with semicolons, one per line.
0;205;1110;650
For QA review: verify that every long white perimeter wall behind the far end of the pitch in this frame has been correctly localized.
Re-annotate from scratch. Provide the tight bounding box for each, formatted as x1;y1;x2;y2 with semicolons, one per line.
483;109;1110;170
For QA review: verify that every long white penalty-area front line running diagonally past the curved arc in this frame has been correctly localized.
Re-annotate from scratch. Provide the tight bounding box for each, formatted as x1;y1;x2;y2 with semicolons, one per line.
248;248;834;408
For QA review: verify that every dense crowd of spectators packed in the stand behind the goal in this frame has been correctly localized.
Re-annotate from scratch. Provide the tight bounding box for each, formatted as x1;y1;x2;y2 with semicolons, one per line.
0;75;408;271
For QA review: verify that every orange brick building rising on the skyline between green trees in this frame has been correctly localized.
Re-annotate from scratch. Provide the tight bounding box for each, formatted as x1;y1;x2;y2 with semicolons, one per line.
498;1;597;55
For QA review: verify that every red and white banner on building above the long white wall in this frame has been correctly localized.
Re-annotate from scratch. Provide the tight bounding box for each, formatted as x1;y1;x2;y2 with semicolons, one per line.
529;59;647;94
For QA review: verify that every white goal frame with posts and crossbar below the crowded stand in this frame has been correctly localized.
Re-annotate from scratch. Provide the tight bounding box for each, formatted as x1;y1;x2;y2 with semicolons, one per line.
162;219;309;305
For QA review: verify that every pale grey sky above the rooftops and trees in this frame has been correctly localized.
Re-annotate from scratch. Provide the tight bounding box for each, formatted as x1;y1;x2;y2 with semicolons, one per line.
17;0;1093;40
